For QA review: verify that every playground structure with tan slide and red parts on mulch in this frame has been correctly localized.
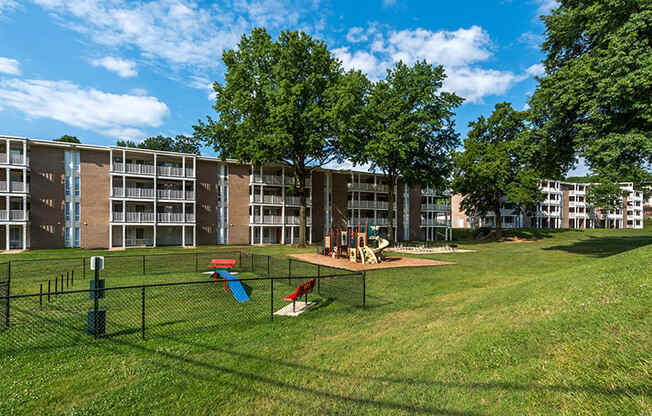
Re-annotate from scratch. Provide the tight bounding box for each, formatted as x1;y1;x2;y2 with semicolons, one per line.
321;223;389;264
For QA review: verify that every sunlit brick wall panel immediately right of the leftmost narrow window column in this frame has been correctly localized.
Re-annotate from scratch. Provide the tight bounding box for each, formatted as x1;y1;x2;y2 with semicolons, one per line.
79;150;111;248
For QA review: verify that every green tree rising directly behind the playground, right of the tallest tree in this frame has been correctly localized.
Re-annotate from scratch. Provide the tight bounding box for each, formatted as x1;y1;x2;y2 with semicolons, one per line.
346;61;463;241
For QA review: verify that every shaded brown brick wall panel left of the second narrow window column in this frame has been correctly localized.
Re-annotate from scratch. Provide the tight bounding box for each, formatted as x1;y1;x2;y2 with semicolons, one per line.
196;160;219;245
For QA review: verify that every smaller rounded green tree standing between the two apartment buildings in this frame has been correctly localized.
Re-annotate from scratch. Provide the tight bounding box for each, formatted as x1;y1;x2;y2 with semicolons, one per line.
453;103;541;237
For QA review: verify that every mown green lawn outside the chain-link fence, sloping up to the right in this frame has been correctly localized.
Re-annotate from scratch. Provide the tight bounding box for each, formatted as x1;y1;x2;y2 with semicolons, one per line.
0;228;652;415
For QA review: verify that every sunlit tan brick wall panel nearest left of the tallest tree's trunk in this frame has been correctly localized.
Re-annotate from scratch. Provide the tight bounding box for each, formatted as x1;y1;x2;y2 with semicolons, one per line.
229;165;250;244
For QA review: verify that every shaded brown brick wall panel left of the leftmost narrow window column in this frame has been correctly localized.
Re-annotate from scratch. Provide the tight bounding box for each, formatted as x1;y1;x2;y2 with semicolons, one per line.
30;145;65;249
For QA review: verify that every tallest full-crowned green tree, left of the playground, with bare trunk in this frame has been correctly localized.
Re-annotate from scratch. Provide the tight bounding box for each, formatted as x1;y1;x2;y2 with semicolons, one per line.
194;28;360;246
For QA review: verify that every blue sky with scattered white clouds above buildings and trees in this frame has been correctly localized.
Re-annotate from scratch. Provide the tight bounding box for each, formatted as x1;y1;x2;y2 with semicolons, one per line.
0;0;582;173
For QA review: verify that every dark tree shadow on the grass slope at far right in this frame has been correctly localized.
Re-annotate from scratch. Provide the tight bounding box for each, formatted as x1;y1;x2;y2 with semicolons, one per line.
543;236;652;257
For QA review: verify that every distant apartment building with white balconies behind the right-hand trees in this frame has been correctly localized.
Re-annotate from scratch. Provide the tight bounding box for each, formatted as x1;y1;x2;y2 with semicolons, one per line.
452;180;644;229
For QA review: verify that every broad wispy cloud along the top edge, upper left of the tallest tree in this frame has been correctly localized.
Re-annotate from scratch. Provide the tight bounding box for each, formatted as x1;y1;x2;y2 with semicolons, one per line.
32;0;314;67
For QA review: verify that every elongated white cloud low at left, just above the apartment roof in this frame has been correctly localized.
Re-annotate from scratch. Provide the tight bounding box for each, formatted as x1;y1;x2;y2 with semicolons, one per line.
0;79;169;137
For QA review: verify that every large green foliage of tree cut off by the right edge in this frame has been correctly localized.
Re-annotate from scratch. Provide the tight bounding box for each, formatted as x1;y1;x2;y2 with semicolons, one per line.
530;0;652;191
